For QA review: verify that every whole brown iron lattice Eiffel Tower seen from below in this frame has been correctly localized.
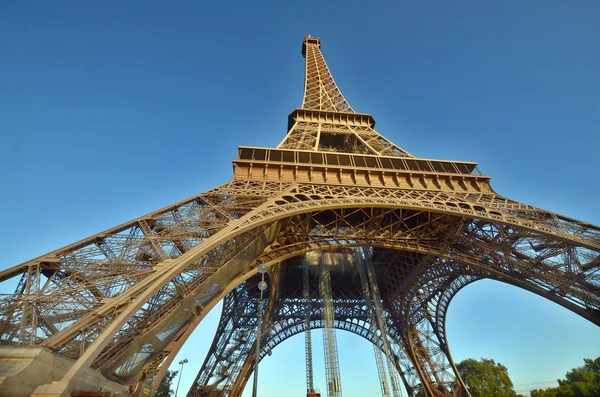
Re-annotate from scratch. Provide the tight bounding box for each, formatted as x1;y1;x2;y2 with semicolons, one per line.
0;36;600;397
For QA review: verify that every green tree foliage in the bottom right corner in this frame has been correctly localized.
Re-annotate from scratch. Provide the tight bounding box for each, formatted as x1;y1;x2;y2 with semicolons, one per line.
531;357;600;397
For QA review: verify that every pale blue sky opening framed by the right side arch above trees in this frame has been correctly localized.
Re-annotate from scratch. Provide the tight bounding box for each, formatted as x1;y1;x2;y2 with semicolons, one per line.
446;279;600;396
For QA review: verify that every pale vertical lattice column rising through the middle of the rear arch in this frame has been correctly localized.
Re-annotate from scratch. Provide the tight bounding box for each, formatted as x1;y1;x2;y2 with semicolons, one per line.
319;257;342;397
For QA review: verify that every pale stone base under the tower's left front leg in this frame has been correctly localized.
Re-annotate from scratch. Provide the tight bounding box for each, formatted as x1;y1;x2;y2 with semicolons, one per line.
0;346;128;397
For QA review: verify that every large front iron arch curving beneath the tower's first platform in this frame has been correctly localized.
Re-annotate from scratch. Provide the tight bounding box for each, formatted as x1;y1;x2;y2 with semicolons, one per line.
1;186;598;396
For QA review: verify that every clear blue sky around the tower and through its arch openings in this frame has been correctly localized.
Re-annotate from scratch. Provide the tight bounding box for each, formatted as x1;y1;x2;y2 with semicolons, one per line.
0;0;600;397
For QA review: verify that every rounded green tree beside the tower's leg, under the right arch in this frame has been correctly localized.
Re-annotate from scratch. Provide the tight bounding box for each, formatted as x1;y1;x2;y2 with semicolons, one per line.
456;358;517;397
